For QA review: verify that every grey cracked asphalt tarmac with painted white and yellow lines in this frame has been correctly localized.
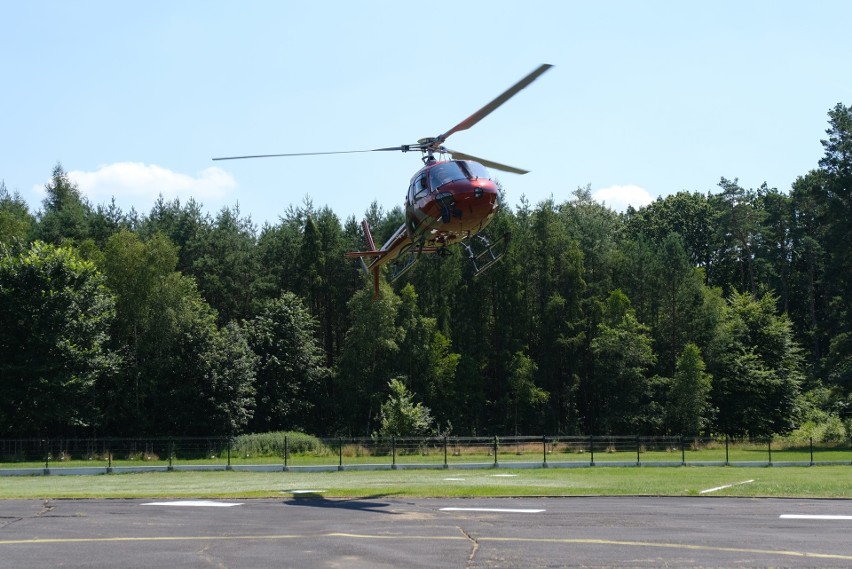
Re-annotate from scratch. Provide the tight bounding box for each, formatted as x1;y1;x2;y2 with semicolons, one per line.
0;490;852;569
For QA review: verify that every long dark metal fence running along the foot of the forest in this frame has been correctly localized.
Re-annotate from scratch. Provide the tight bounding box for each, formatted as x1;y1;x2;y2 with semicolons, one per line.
0;435;852;475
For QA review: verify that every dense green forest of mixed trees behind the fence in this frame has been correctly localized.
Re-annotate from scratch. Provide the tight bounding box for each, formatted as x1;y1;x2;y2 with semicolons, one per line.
0;103;852;440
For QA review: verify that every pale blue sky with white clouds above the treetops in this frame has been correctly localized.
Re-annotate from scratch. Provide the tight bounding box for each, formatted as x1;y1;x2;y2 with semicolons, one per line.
0;0;852;225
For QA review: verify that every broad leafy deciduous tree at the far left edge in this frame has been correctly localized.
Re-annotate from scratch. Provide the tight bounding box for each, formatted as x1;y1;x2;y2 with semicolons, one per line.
0;242;119;436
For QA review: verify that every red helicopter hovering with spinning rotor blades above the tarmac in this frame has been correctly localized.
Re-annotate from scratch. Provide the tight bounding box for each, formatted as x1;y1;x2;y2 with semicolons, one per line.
213;63;552;296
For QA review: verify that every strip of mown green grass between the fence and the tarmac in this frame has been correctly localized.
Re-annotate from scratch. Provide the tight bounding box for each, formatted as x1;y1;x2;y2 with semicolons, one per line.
0;466;852;499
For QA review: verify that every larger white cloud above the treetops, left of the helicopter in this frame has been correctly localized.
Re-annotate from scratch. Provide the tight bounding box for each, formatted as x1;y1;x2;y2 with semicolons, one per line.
61;162;237;208
